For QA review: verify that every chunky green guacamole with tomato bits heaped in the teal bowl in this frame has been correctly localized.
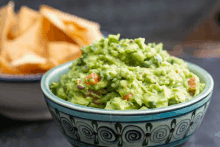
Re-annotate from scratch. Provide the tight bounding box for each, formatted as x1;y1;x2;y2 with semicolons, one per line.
50;34;205;110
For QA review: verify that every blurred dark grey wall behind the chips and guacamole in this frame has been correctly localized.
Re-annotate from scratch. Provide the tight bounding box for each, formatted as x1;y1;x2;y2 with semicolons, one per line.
0;0;220;50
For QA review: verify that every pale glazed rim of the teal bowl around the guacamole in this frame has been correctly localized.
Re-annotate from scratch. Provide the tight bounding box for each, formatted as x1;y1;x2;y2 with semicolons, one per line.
41;60;214;115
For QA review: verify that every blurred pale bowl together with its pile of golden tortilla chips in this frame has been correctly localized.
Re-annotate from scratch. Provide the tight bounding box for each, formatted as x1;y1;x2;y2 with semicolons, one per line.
0;1;102;120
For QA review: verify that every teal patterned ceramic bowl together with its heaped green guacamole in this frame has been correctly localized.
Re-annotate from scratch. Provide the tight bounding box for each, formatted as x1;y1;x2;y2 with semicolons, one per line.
41;34;214;147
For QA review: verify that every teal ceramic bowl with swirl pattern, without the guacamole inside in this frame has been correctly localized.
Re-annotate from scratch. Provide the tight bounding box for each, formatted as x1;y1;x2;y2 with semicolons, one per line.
41;62;214;147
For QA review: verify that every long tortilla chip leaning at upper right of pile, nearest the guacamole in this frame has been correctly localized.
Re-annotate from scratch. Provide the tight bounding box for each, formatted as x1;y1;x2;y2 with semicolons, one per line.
40;6;102;47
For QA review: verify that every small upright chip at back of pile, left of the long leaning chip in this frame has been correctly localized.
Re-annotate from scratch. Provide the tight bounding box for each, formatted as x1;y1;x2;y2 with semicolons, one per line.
18;6;42;34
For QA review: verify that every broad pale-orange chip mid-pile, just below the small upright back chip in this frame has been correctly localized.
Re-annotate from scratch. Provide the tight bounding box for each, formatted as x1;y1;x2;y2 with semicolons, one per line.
4;18;47;61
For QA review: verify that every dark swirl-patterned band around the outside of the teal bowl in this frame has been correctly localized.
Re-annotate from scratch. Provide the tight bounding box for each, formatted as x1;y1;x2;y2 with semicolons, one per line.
48;100;210;147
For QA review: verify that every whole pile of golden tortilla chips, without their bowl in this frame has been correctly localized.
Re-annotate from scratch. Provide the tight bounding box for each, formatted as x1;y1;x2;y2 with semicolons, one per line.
0;1;101;74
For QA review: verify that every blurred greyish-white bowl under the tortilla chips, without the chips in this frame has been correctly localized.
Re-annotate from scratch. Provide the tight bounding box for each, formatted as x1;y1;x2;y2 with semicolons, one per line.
0;74;52;120
